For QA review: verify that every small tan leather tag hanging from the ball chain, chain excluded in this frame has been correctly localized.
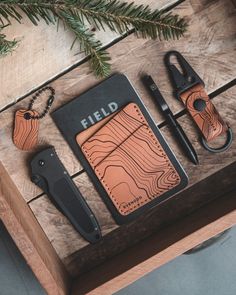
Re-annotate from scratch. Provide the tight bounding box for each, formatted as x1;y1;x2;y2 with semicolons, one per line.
13;110;39;151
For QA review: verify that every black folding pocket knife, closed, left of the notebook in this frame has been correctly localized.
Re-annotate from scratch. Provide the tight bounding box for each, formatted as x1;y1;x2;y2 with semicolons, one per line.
31;147;102;243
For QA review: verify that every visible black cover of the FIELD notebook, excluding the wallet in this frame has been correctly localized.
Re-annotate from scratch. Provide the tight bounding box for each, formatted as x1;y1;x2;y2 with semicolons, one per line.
52;74;188;224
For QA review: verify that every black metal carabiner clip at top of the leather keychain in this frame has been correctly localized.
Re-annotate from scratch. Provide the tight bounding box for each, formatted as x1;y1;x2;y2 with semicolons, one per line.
164;50;205;98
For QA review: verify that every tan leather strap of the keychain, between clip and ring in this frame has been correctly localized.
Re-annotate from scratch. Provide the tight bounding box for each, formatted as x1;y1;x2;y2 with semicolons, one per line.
180;84;228;141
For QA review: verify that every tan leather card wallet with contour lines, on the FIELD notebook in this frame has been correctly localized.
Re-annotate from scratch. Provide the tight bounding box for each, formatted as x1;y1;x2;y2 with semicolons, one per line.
77;103;180;215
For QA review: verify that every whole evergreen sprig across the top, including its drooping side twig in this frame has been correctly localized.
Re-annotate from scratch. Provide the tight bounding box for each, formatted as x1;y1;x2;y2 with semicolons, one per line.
0;0;187;77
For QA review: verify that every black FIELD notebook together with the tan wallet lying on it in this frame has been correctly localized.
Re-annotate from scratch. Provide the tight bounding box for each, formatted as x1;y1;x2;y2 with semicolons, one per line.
52;74;187;224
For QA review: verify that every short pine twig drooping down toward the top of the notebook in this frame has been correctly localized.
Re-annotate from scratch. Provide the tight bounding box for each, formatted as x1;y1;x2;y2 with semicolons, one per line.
59;11;110;77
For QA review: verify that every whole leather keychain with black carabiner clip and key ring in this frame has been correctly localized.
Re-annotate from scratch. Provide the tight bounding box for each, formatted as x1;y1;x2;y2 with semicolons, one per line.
165;51;233;153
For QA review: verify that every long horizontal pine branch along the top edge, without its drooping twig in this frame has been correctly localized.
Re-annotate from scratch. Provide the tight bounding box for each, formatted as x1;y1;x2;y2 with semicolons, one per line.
0;0;187;39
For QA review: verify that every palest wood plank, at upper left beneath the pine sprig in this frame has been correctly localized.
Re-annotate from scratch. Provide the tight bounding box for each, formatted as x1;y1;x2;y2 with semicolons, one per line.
0;0;176;110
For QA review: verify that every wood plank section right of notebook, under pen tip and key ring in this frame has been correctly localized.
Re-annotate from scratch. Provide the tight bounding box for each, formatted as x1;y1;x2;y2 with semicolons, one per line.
159;86;236;186
